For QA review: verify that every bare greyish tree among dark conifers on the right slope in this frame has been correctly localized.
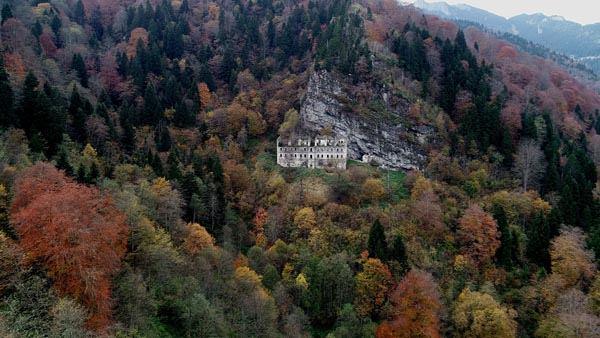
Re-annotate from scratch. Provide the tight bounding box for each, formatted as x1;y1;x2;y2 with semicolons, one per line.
514;139;544;191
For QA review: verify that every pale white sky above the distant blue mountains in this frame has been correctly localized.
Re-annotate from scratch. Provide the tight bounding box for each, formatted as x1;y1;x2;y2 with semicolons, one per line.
408;0;600;24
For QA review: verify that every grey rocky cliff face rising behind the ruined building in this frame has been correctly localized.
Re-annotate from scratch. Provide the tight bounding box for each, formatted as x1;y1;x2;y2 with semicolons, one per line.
300;71;433;170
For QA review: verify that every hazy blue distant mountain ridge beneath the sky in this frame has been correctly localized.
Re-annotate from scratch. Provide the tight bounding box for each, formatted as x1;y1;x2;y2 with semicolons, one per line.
414;0;600;73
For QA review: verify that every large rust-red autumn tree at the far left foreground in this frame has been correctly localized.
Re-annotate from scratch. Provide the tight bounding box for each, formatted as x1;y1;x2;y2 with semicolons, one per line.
11;163;127;329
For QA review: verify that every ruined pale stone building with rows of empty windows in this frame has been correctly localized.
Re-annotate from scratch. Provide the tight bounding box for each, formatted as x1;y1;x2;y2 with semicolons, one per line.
277;136;348;170
